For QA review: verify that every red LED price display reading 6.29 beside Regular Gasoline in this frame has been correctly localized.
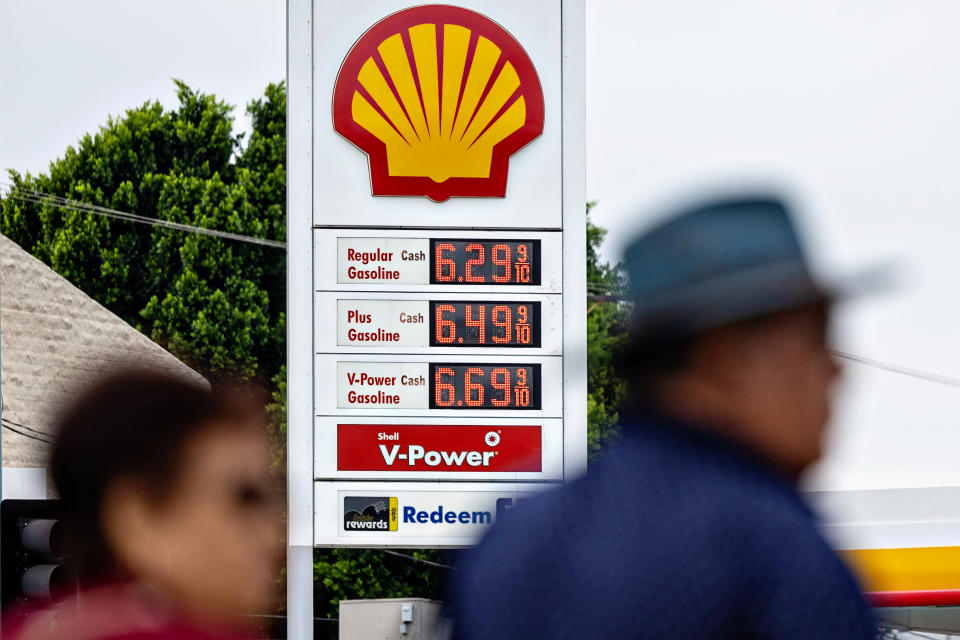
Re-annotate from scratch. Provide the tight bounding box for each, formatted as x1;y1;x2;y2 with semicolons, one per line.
430;240;540;285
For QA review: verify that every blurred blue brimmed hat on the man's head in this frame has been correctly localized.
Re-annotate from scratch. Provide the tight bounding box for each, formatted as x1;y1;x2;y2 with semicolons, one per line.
624;194;868;343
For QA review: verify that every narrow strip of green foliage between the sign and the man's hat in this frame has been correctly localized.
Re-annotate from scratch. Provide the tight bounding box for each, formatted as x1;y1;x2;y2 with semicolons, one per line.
587;202;629;457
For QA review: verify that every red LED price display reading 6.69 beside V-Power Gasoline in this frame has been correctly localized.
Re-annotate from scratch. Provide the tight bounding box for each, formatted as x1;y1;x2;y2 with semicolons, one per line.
430;363;540;409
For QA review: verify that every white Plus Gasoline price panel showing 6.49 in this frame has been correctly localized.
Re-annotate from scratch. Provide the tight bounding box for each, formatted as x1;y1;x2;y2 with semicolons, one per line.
314;291;563;357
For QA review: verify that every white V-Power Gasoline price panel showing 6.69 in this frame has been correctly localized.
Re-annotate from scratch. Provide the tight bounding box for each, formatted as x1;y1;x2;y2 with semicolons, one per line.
314;353;563;418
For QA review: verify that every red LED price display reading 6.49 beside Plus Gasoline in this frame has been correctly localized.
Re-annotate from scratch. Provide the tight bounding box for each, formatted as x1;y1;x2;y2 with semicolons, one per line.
430;301;540;347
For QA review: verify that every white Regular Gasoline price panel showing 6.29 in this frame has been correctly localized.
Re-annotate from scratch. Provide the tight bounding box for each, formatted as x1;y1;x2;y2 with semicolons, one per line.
314;229;563;294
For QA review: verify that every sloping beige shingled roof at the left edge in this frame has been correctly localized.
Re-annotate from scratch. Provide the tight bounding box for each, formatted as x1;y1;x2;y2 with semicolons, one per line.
0;235;206;467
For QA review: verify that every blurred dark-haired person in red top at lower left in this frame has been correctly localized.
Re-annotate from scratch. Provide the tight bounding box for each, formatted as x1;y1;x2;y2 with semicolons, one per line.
4;371;283;640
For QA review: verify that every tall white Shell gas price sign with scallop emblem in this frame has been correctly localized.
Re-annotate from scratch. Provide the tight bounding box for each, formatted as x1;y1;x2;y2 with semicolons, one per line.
287;0;586;568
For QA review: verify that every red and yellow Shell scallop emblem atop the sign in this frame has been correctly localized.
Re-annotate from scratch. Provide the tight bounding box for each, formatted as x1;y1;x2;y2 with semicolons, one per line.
333;5;543;202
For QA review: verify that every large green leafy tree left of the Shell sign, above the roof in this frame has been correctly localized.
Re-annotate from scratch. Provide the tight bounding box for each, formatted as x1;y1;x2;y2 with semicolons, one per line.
0;82;286;379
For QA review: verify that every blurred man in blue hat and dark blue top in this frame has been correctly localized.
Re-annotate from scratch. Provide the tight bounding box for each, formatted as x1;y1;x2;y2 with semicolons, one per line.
454;194;877;640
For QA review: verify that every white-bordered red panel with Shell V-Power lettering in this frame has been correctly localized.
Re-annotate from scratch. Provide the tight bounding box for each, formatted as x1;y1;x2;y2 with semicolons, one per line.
314;416;563;481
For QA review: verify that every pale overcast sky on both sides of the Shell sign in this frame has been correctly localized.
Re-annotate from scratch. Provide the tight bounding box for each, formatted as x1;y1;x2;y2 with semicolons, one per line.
0;0;960;488
